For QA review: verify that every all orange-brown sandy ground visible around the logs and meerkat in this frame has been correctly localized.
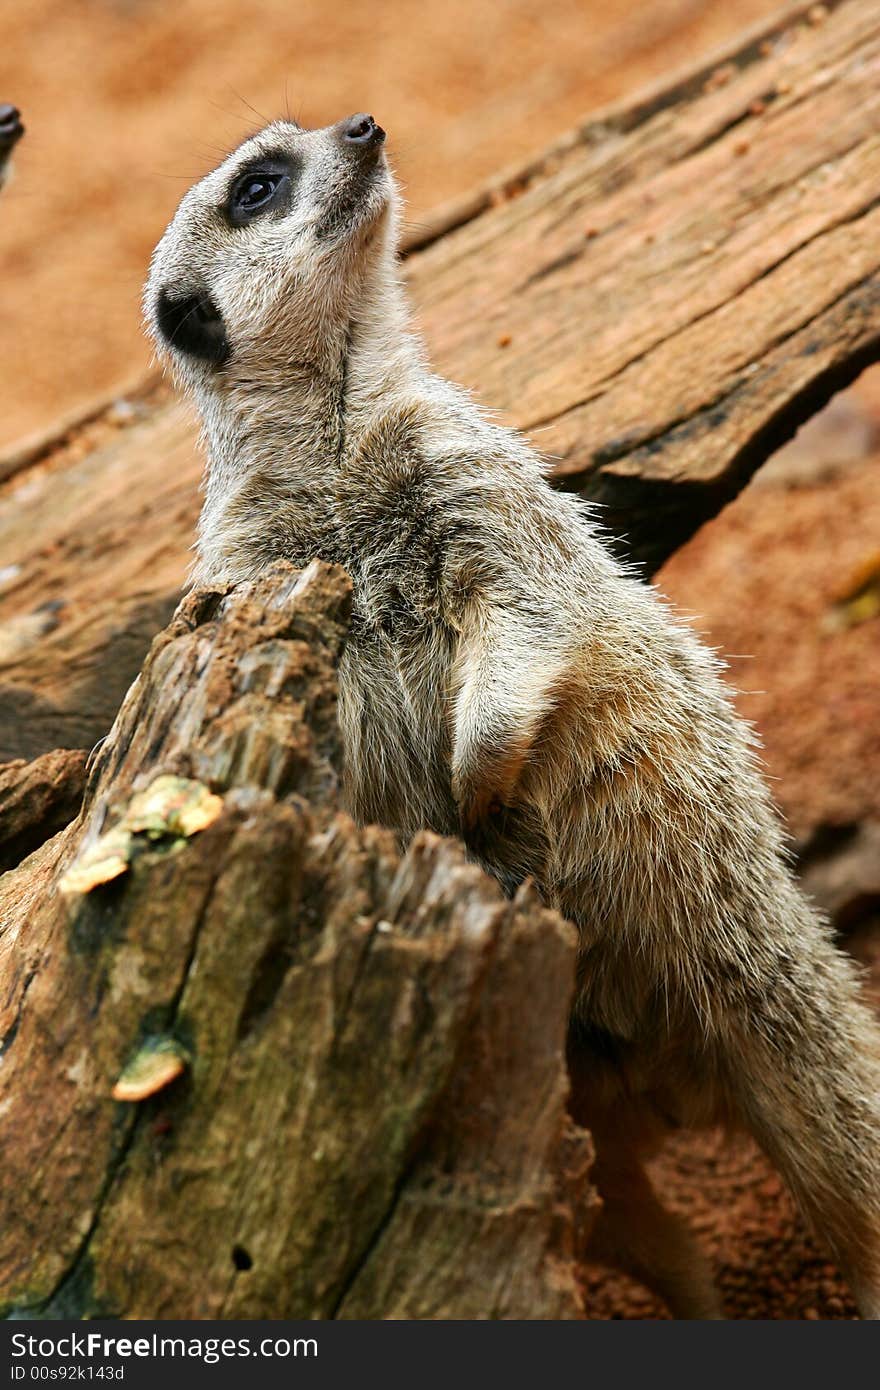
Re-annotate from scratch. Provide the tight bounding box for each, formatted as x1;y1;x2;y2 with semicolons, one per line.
0;0;880;1318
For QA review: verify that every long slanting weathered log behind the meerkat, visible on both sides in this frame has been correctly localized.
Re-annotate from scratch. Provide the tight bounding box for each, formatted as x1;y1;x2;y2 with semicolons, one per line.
0;0;880;758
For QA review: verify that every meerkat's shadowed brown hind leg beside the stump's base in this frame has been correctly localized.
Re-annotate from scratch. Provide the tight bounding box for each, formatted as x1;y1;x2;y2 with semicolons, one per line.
587;1144;723;1319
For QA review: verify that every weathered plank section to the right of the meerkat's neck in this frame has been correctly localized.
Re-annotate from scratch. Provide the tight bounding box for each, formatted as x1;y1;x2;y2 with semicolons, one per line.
410;0;880;573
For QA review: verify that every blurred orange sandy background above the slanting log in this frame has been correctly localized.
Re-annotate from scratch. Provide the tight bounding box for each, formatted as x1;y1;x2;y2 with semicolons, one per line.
0;0;777;449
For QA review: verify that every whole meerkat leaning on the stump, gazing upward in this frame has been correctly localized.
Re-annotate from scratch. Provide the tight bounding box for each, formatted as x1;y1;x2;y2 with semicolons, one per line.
145;115;880;1318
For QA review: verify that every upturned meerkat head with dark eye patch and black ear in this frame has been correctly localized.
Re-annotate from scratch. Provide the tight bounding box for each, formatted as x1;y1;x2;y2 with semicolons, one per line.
145;115;396;386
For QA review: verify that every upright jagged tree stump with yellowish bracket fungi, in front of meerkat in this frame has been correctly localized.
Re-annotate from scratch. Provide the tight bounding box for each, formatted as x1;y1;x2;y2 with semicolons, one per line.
0;563;589;1318
